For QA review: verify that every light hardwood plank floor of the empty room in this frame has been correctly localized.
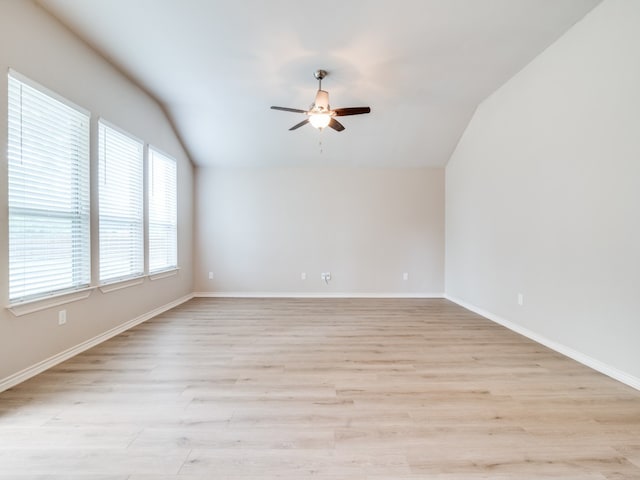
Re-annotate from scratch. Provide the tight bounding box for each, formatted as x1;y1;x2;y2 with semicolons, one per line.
0;299;640;480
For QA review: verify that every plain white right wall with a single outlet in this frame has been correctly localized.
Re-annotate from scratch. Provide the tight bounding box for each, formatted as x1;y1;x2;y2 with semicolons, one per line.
446;0;640;382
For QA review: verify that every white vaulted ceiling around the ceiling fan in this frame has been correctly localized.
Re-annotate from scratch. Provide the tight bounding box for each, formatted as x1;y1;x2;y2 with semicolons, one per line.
37;0;600;167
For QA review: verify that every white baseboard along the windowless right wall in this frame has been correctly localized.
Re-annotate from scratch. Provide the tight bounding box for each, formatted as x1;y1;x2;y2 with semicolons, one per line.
444;294;640;390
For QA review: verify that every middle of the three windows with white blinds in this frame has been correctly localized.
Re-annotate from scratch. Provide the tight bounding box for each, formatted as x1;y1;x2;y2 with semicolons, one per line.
98;120;144;284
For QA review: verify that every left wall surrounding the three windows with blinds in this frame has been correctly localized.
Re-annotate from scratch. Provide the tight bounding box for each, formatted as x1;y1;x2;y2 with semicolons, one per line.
0;0;194;389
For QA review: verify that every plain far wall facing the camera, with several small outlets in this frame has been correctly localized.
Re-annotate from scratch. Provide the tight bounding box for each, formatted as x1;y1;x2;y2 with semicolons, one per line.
195;167;444;296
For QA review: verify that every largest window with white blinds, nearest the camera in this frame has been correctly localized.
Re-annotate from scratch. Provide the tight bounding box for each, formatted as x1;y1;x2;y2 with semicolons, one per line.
7;71;91;302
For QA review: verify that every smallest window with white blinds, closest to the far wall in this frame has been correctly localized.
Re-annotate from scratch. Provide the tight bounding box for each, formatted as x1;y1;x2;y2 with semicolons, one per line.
149;148;178;273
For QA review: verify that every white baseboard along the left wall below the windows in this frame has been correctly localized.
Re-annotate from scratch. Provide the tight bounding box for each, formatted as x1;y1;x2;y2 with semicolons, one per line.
0;294;194;392
